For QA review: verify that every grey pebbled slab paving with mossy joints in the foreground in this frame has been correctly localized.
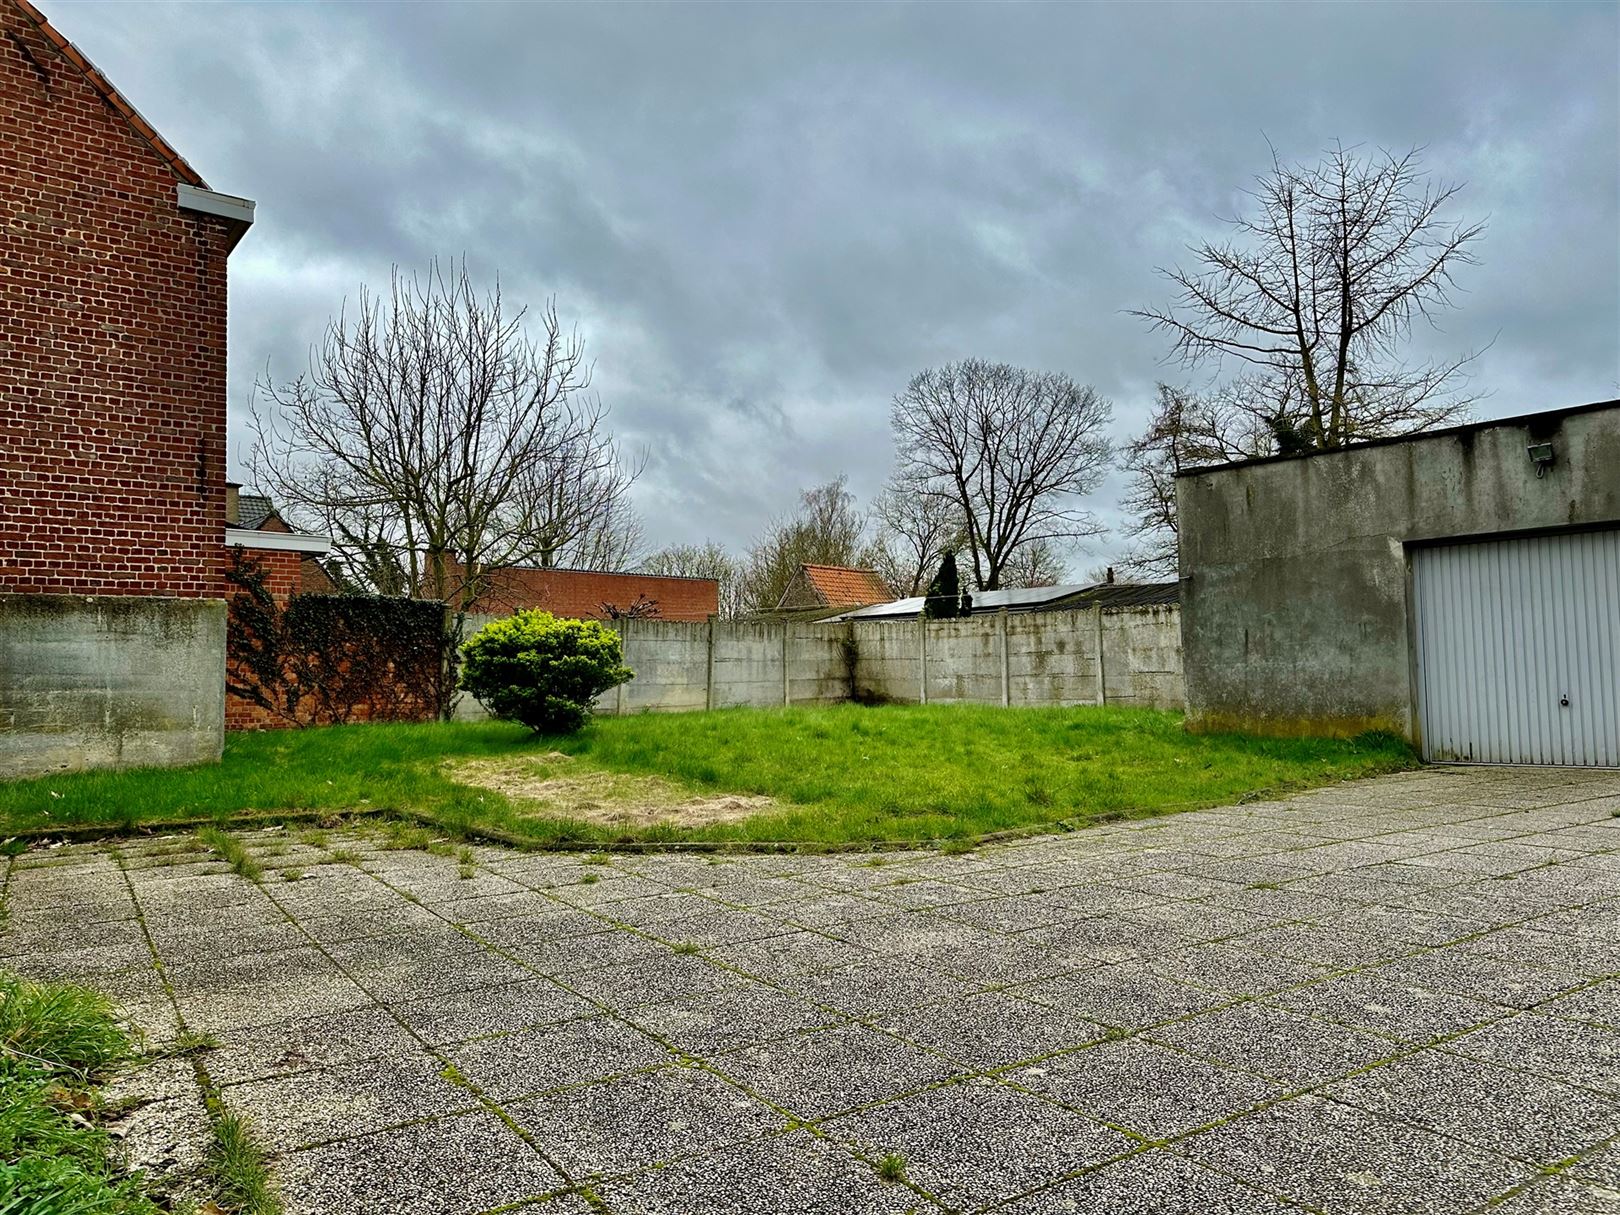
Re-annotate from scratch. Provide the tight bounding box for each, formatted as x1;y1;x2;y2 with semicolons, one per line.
3;770;1620;1215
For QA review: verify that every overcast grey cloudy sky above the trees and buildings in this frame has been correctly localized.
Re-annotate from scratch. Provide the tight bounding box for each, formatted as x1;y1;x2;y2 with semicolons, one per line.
42;0;1620;572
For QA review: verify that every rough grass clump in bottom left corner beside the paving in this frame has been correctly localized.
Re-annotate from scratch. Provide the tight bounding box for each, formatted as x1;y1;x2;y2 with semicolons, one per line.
0;974;160;1215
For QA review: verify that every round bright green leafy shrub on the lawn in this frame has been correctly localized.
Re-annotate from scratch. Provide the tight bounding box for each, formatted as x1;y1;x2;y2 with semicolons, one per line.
462;611;635;734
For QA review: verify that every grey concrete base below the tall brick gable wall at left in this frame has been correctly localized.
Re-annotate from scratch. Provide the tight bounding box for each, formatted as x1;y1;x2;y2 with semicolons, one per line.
0;595;225;778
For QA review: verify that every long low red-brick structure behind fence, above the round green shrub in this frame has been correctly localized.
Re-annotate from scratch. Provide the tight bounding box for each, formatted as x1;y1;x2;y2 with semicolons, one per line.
470;565;719;620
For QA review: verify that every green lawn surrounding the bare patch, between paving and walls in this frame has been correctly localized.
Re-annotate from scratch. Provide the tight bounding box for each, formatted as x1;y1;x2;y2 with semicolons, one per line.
0;705;1416;844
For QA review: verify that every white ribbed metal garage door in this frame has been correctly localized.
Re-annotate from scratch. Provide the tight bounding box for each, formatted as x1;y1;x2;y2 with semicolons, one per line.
1413;530;1620;766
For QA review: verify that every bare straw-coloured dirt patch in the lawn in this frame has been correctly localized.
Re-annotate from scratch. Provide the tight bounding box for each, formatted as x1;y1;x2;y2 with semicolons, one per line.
447;752;779;828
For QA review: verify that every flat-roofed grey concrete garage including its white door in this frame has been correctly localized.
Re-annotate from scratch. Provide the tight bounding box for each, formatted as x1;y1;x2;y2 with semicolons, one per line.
1176;402;1620;766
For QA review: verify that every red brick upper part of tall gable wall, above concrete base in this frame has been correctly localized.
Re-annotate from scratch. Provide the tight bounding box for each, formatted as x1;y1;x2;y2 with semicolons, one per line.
0;0;232;596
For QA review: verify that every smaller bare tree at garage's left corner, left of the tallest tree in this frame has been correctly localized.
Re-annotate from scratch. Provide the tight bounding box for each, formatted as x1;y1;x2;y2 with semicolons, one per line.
1119;376;1286;578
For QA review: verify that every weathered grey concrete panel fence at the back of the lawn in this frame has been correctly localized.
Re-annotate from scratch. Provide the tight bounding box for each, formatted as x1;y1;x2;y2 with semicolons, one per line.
458;608;1186;718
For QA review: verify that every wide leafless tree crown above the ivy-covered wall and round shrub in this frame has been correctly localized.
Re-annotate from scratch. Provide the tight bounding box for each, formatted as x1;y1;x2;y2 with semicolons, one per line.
249;262;637;622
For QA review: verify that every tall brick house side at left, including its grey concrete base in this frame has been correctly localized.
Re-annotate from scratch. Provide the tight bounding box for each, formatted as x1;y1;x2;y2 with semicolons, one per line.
0;0;285;776
